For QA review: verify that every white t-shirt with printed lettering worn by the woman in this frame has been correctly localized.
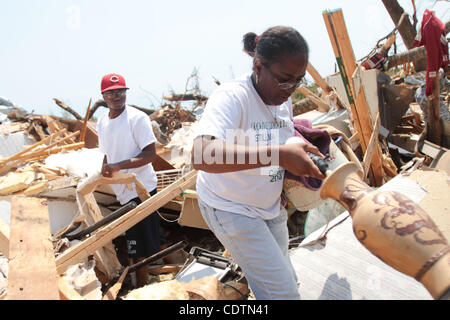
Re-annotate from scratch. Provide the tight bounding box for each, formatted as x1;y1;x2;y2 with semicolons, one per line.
194;74;294;219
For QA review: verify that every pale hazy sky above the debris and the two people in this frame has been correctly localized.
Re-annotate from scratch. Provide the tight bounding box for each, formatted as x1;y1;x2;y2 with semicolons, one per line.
0;0;450;116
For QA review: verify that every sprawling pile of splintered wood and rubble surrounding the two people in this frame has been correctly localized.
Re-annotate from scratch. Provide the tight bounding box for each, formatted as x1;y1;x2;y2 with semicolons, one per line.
0;1;450;300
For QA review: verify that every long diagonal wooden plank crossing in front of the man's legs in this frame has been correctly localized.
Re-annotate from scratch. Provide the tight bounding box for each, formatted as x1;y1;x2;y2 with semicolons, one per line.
56;170;197;273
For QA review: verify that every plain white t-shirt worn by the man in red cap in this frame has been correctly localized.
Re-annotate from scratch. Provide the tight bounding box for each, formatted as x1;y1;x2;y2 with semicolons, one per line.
97;105;157;205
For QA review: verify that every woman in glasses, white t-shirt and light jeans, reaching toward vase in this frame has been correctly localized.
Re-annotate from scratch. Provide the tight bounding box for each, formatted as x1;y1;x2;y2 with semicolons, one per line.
192;27;325;299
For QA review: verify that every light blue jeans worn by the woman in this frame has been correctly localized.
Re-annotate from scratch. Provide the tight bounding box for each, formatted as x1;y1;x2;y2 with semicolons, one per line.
198;199;300;300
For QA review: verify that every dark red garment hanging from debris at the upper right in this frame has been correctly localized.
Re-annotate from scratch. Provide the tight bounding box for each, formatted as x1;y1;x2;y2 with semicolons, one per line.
413;9;449;96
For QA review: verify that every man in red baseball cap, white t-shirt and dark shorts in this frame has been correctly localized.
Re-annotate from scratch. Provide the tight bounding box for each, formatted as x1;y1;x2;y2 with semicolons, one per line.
97;73;161;287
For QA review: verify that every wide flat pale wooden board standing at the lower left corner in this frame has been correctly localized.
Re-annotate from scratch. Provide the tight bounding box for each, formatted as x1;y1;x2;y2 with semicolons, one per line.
7;196;59;300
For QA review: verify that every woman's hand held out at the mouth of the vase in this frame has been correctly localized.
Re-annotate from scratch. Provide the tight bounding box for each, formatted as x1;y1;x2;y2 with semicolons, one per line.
279;142;325;179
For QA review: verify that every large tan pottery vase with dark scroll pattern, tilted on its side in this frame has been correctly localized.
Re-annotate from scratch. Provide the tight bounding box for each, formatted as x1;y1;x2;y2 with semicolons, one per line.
320;162;450;299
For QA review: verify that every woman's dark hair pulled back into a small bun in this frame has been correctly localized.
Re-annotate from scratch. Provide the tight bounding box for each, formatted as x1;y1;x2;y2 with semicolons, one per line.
242;26;309;64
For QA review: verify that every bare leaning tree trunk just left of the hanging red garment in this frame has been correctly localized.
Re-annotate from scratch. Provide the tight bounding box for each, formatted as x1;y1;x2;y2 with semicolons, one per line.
381;0;427;71
